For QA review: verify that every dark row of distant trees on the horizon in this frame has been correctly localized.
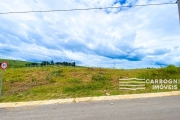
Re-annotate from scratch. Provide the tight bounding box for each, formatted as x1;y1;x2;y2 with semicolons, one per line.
26;60;76;67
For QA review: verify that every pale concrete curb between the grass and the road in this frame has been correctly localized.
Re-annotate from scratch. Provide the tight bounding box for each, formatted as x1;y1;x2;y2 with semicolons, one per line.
0;91;180;108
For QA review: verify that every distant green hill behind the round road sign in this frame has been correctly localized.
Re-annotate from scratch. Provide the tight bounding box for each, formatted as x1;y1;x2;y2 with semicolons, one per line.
0;59;32;67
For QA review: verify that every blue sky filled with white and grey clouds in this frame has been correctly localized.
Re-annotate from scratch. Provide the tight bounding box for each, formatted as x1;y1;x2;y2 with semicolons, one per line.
0;0;180;68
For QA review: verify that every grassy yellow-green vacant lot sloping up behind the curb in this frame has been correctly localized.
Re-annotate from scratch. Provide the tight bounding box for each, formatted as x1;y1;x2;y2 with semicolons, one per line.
1;66;180;102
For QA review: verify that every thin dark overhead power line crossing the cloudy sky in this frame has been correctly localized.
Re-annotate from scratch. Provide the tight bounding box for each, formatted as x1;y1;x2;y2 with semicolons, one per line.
0;2;177;14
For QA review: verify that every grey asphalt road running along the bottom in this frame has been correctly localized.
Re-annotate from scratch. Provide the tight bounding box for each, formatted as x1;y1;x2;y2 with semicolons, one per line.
0;96;180;120
